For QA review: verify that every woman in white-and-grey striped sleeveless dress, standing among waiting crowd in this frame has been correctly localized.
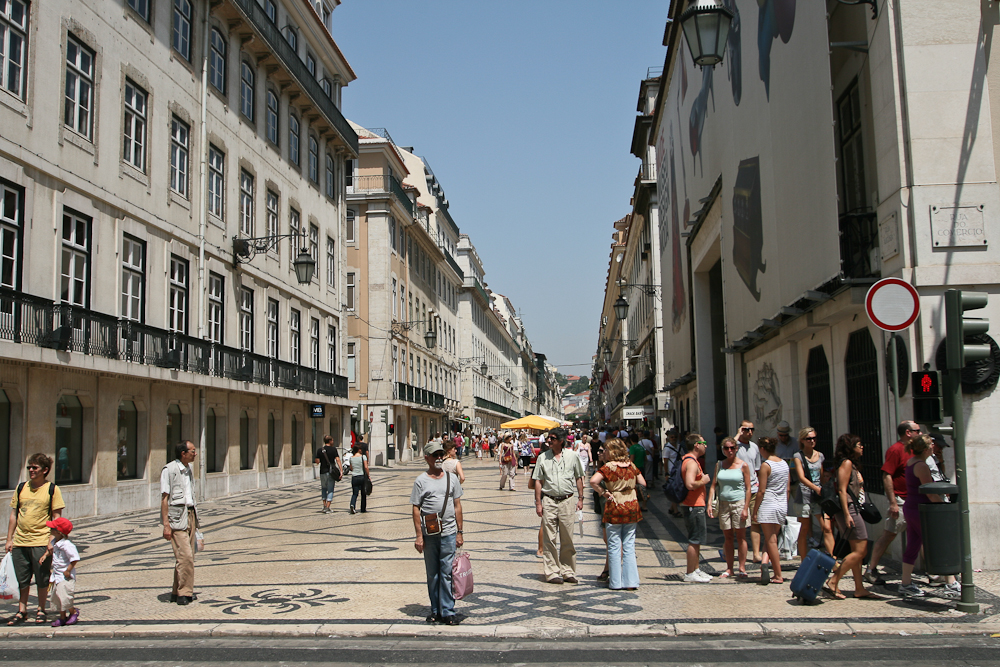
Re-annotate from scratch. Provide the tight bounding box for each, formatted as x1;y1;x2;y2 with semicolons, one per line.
753;438;788;584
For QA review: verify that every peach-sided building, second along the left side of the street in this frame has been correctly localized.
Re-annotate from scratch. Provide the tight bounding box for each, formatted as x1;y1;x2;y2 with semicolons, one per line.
346;125;462;464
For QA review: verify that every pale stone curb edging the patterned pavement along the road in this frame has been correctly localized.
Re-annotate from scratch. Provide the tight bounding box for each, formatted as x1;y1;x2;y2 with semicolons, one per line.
0;619;1000;639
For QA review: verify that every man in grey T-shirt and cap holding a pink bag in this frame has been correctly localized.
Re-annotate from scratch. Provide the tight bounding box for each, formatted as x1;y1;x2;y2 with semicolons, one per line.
410;442;464;625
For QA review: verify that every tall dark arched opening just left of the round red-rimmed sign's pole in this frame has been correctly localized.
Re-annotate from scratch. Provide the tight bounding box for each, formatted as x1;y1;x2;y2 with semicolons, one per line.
844;329;884;493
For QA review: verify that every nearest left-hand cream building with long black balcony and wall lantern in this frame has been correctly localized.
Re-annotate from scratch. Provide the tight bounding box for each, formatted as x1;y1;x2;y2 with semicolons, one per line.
0;0;358;517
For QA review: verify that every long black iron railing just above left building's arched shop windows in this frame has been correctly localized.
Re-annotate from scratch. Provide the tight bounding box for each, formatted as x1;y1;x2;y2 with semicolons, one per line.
0;289;347;398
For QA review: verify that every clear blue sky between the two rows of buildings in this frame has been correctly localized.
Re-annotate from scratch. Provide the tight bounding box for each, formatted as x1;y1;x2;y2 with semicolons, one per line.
333;0;669;375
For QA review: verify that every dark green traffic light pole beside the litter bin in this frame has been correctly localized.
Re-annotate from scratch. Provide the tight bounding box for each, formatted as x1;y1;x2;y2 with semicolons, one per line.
944;289;979;614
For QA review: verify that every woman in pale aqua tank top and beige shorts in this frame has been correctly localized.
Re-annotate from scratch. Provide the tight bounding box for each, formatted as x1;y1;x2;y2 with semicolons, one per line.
708;438;750;579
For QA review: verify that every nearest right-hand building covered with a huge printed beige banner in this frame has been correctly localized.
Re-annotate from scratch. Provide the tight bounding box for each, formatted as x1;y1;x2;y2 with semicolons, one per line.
639;0;1000;567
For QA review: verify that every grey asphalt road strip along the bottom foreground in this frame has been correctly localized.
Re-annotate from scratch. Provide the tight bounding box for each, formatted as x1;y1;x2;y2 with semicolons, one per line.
0;636;1000;667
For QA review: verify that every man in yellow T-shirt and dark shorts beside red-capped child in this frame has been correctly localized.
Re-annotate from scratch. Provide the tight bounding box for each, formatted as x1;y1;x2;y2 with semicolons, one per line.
5;454;66;625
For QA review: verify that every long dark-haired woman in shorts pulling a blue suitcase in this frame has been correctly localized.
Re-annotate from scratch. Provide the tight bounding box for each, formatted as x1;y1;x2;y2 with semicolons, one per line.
823;433;876;600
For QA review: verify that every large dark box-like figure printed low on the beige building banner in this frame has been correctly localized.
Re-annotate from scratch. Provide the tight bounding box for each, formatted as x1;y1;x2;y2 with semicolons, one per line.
733;156;767;301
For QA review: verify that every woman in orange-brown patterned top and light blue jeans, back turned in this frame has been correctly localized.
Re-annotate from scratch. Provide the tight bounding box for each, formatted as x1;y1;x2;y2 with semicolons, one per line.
590;438;645;591
